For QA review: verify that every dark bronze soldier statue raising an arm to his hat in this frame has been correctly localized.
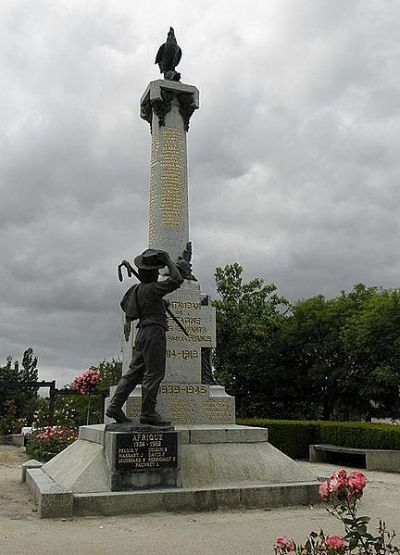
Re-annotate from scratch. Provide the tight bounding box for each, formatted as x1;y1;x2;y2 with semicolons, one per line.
106;249;183;426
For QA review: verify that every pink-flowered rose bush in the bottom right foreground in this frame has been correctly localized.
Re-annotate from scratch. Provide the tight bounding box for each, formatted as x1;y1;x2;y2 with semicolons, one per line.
274;469;400;555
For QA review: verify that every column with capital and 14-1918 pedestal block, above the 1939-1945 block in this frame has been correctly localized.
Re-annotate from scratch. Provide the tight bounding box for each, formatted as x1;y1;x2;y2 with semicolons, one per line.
140;79;206;383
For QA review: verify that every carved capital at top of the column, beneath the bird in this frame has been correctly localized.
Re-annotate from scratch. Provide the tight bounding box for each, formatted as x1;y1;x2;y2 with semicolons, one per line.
140;79;199;131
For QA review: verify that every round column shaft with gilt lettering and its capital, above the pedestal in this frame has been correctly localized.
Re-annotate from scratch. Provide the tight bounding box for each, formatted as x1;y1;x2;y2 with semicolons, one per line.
140;79;199;260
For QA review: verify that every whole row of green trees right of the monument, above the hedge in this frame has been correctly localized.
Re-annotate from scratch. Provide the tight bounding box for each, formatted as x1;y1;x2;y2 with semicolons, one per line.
213;263;400;420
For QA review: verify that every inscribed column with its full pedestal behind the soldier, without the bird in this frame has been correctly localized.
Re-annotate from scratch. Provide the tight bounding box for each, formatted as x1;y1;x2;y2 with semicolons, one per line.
119;33;235;424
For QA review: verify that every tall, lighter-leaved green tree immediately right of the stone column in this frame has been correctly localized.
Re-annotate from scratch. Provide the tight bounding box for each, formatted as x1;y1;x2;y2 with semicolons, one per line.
213;263;289;415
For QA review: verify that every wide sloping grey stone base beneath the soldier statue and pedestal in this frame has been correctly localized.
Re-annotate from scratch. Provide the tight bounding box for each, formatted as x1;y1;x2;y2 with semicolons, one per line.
25;424;319;518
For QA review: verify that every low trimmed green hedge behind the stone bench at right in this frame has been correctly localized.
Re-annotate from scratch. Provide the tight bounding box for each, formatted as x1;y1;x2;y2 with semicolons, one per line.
236;418;400;459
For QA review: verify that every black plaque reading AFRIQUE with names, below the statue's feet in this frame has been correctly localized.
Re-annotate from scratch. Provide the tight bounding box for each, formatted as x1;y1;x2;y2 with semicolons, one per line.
116;432;178;472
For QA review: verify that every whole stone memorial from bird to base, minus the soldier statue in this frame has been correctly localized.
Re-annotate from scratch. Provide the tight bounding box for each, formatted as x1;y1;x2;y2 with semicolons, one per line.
24;29;319;518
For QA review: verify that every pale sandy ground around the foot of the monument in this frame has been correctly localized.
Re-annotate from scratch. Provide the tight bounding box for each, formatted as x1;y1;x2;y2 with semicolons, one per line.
0;446;400;555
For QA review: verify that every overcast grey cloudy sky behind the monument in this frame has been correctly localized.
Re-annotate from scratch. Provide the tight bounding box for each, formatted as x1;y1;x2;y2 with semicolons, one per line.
0;0;400;386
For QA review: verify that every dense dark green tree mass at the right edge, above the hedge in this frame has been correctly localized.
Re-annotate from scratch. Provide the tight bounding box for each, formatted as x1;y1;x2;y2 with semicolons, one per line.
282;284;400;420
